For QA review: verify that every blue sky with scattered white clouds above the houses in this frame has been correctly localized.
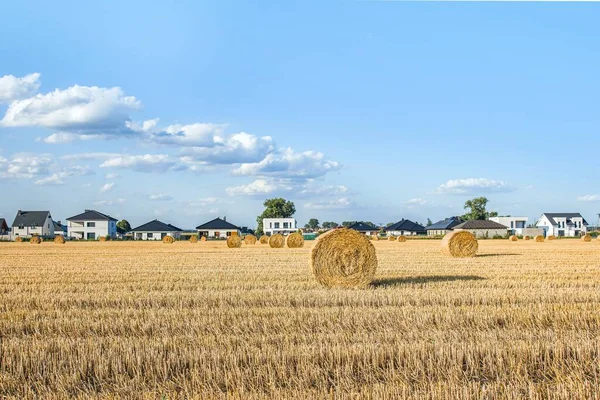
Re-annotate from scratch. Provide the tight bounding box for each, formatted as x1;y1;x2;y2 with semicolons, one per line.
0;1;600;228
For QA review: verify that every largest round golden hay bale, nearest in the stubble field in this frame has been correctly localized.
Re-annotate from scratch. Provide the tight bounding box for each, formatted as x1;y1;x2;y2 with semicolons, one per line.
310;229;377;287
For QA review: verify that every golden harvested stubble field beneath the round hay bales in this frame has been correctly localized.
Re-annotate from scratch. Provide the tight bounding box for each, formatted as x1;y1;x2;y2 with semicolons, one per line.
0;240;600;399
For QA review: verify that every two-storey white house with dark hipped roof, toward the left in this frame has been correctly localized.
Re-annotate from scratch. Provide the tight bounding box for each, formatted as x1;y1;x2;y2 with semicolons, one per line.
67;210;117;240
